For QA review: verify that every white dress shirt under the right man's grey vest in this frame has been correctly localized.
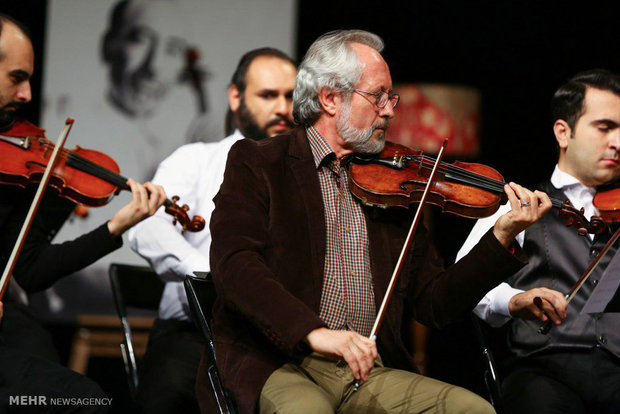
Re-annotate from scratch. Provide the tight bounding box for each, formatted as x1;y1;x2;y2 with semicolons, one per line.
456;165;598;327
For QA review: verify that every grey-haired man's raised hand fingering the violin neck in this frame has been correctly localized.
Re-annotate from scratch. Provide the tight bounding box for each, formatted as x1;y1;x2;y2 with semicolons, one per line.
493;183;551;248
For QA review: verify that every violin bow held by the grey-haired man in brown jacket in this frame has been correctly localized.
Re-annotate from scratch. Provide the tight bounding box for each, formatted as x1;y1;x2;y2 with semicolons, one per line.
354;138;448;391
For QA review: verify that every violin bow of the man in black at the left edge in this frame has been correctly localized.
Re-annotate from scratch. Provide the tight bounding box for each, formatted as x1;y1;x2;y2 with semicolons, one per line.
0;118;73;300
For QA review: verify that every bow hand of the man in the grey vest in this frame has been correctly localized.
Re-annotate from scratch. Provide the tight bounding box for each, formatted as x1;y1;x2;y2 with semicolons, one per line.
508;288;568;325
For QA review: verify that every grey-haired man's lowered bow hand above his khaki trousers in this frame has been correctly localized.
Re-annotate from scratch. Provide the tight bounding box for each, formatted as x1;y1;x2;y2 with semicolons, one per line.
306;328;378;381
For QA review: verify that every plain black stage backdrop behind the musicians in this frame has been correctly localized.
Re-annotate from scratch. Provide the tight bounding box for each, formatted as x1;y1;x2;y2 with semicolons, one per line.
0;0;620;402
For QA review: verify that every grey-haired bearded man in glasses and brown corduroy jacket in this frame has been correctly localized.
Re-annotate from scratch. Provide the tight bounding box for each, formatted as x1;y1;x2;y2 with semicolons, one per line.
202;30;551;413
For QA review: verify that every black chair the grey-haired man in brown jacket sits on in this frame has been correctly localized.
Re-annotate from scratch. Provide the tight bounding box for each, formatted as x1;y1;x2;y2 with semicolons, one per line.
184;272;237;414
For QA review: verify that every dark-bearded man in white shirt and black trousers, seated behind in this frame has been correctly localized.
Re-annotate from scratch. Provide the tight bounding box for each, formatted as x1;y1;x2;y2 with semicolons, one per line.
129;48;297;413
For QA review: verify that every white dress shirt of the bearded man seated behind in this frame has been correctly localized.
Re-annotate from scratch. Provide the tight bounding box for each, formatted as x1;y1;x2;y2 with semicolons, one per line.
128;130;243;320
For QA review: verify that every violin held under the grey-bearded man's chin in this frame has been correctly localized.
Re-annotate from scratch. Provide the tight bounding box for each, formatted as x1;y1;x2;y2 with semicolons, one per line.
349;141;604;235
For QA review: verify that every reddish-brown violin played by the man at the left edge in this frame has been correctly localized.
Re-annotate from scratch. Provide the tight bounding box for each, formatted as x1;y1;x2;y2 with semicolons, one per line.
0;120;205;232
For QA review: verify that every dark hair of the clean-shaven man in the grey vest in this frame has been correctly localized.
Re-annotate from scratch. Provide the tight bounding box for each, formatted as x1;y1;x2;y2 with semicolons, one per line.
551;69;620;130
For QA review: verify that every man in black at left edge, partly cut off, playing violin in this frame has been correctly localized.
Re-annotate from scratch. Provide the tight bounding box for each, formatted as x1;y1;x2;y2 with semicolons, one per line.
0;14;166;412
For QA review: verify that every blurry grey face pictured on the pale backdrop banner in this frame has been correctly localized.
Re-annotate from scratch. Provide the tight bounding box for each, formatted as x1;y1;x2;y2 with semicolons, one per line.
102;0;187;117
